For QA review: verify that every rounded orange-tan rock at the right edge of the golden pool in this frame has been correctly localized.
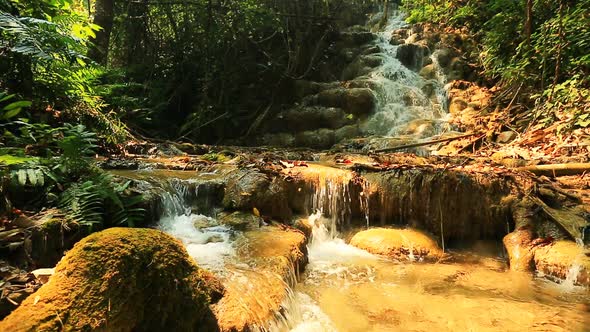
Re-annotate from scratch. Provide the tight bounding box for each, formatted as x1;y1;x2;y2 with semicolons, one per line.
534;241;590;286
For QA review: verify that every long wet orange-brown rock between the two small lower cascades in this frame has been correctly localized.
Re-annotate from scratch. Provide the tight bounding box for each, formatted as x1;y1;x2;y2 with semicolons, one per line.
213;226;307;331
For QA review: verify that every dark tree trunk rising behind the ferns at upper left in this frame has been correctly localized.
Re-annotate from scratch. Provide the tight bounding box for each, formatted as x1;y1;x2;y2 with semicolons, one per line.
88;0;114;65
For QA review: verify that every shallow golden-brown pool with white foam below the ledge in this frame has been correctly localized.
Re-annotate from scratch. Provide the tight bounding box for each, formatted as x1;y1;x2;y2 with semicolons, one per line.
279;215;590;331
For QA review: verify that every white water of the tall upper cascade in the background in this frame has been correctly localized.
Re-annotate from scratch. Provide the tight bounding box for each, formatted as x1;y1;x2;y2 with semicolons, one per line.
363;11;454;138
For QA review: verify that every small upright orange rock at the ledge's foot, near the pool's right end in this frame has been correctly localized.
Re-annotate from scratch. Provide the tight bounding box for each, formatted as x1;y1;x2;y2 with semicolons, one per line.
502;227;534;272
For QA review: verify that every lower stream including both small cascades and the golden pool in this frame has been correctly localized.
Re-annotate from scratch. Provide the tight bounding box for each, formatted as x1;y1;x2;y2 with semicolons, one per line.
148;177;590;332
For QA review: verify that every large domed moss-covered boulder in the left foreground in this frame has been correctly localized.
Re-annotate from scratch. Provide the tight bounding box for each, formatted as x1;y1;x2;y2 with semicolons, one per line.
0;228;222;332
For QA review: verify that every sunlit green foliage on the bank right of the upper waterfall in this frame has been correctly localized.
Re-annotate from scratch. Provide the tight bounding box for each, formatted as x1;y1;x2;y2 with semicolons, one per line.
403;0;590;130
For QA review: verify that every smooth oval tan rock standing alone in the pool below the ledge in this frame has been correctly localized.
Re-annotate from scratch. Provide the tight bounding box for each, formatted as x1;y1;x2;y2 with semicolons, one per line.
350;228;443;261
